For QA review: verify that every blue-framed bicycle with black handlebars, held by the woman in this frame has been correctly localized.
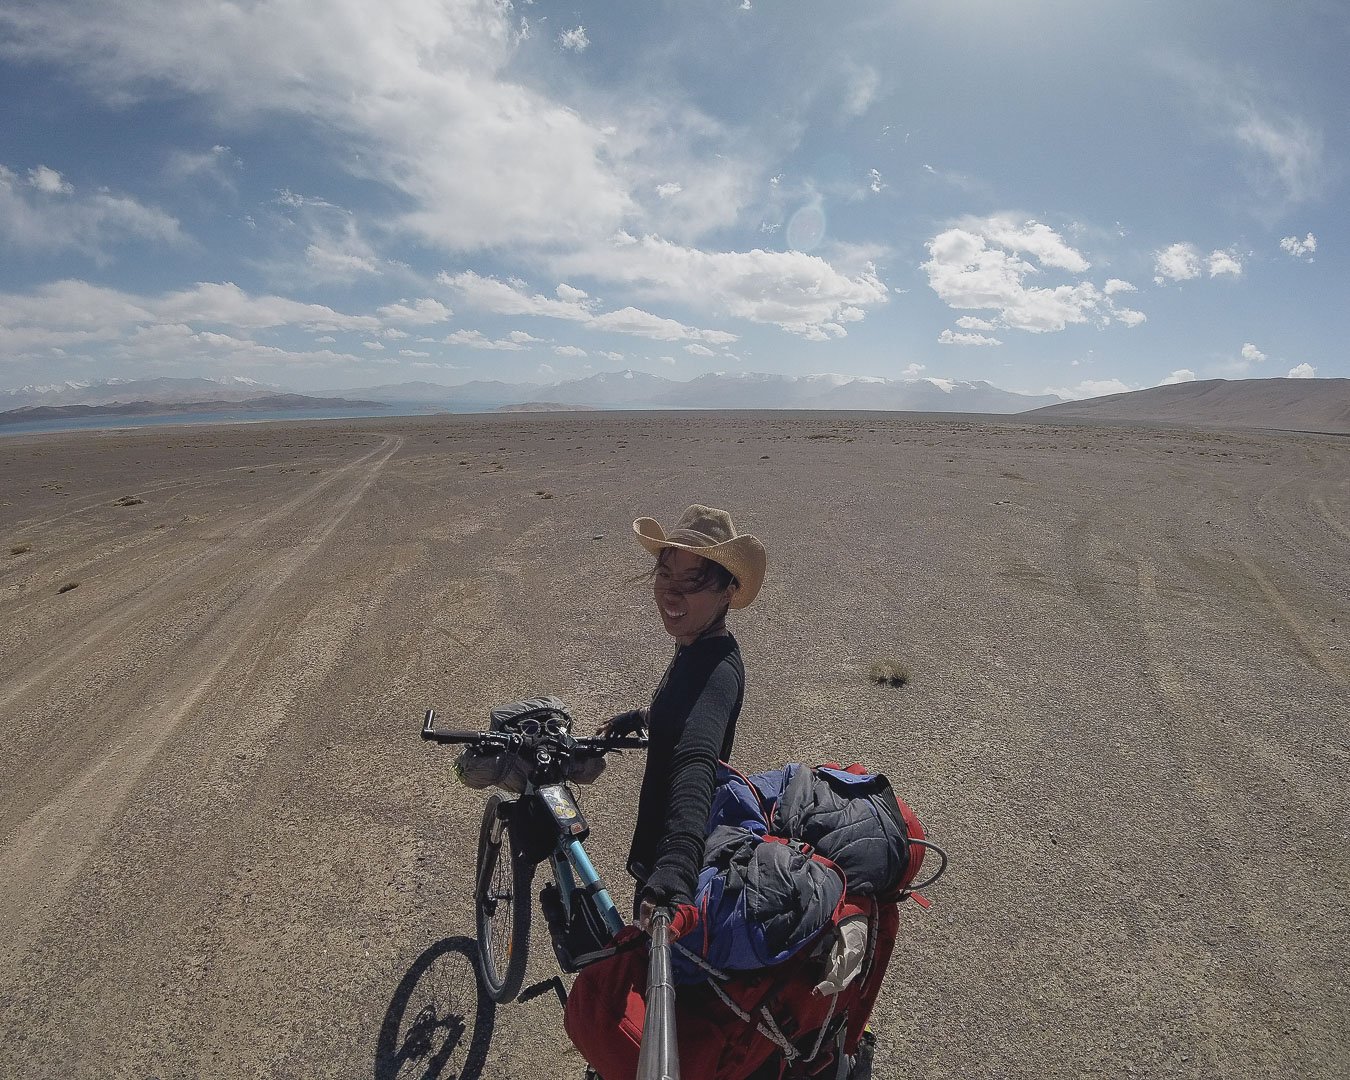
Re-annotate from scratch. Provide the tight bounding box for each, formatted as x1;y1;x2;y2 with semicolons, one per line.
421;706;647;1002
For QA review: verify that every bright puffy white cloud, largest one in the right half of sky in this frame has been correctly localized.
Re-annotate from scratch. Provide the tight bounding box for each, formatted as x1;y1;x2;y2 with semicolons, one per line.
922;215;1142;333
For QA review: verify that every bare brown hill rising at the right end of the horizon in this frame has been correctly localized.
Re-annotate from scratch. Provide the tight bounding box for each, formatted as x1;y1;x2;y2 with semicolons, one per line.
1031;379;1350;435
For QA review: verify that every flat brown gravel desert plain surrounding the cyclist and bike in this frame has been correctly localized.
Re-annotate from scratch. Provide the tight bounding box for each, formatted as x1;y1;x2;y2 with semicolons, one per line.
0;413;1350;1080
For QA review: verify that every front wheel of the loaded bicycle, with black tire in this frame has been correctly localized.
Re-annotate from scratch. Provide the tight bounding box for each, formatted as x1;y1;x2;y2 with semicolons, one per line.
474;794;535;1002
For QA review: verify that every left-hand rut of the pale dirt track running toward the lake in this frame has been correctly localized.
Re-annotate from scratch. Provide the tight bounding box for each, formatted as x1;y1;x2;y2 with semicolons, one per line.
0;436;402;711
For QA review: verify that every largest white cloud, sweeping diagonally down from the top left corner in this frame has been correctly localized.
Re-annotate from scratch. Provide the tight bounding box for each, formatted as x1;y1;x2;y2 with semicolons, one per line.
0;0;637;250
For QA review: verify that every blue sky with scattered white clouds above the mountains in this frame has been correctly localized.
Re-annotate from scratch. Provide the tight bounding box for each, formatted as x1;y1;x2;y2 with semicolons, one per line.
0;0;1350;397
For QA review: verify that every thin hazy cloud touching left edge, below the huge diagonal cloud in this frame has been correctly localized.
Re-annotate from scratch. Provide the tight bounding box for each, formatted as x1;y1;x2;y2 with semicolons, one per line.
0;165;189;263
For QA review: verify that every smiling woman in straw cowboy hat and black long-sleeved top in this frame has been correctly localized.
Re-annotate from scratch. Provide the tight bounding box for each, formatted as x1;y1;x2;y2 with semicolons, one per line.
601;505;765;936
